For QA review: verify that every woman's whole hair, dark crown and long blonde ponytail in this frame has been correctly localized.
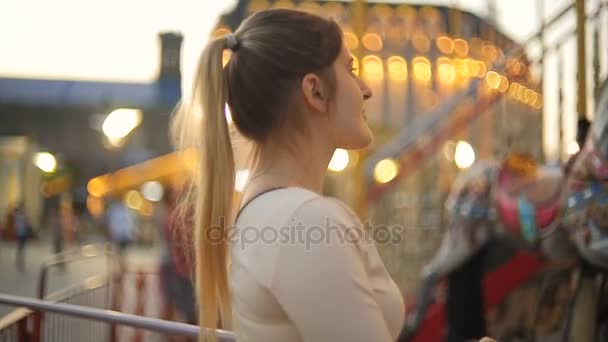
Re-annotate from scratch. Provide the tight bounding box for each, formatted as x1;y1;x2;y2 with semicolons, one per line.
171;9;342;341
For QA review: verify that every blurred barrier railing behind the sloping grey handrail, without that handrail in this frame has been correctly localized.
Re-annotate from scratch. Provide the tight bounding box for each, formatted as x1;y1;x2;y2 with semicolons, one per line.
0;244;200;342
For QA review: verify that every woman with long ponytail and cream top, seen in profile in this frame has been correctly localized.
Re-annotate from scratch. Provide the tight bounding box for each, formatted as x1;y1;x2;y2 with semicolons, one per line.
174;10;404;341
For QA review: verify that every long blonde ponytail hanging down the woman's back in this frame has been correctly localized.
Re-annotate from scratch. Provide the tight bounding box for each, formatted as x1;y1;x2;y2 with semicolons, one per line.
172;37;234;341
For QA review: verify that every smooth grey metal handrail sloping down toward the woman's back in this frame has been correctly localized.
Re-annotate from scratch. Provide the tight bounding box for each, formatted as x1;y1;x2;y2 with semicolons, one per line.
0;294;236;342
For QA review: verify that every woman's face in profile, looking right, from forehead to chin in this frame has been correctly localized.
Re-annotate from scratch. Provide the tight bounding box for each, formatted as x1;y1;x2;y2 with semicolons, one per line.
326;44;373;149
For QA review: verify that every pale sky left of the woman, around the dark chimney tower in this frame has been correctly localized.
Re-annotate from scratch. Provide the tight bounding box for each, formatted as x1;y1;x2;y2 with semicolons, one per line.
0;0;234;87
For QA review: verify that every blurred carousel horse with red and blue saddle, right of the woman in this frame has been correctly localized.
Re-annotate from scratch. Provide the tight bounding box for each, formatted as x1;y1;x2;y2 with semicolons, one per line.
399;82;608;342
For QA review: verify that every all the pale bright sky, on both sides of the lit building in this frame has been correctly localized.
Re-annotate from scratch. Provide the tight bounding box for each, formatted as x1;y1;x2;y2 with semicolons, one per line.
0;0;608;160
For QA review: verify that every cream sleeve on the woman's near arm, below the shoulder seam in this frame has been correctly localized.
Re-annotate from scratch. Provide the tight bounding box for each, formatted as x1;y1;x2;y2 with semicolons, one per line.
270;198;392;342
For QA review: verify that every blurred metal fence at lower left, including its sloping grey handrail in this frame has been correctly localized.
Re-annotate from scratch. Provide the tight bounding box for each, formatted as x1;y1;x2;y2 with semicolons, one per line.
0;245;232;342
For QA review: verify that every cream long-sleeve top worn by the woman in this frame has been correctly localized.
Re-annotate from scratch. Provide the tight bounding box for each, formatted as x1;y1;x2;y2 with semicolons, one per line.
230;188;404;342
